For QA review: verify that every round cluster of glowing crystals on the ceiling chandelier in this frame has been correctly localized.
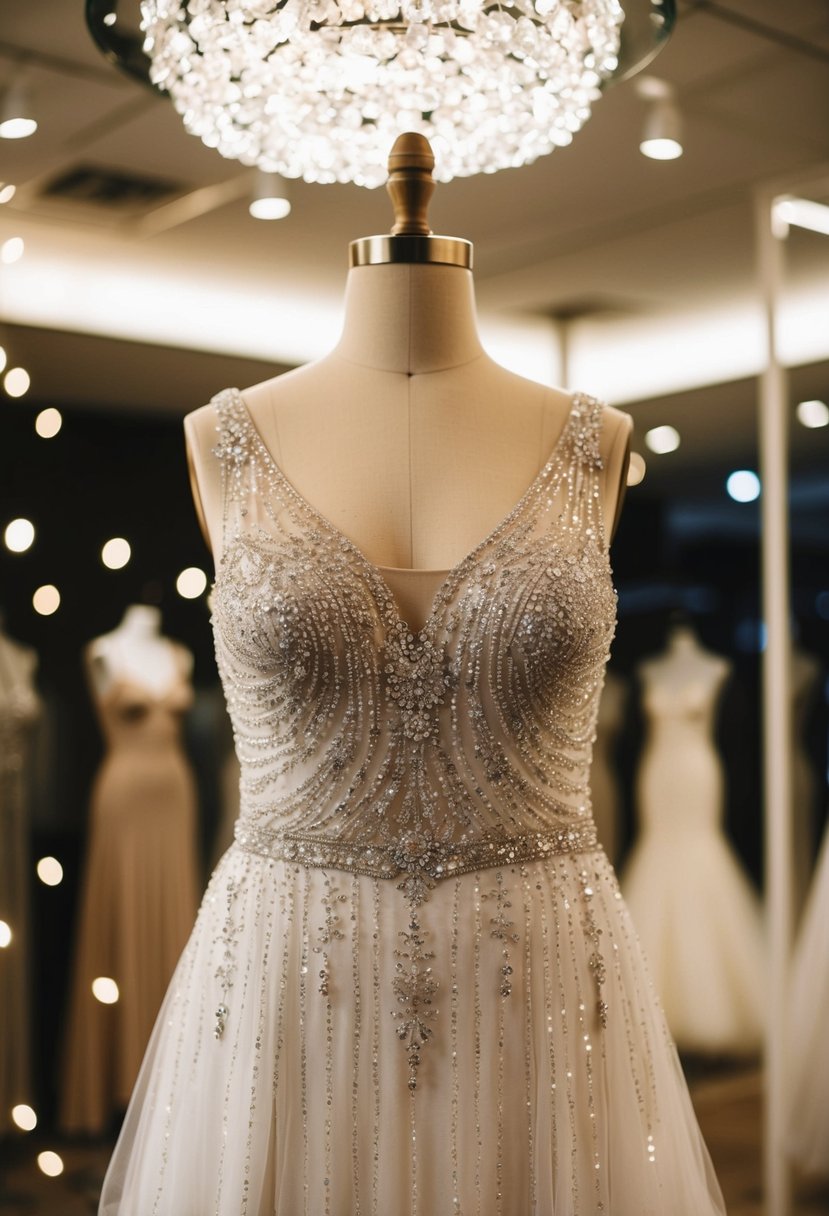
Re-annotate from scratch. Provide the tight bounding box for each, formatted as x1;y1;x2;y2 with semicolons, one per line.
141;0;625;186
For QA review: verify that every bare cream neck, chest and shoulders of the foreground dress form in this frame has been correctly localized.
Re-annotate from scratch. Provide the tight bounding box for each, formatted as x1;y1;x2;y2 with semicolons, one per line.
185;136;632;586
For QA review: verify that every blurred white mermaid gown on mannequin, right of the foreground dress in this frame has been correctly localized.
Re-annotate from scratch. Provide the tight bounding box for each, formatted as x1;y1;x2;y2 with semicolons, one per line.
622;627;765;1054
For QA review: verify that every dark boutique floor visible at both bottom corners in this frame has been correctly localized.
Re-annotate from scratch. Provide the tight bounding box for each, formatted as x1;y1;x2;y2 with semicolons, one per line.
0;1060;829;1216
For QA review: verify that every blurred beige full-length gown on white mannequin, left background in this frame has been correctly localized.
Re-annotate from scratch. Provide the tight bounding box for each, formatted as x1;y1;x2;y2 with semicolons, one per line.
61;606;198;1133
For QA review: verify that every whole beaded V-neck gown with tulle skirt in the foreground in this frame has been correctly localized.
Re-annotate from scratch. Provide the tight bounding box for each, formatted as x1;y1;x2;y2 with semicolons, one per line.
100;390;724;1216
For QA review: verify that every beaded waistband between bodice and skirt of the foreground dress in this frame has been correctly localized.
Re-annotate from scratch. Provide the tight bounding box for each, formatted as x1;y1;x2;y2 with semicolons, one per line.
235;820;599;886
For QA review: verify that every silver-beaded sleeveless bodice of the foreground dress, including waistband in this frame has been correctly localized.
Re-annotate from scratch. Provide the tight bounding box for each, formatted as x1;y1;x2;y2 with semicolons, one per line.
213;389;615;902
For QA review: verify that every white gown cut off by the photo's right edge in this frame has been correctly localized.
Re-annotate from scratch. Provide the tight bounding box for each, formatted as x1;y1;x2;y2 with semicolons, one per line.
789;827;829;1177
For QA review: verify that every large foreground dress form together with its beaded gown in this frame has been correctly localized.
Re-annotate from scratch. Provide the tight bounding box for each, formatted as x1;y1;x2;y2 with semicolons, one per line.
100;136;723;1216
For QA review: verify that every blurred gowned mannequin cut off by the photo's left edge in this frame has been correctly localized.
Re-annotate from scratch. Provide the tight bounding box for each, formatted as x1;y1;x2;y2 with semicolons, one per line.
0;629;40;1132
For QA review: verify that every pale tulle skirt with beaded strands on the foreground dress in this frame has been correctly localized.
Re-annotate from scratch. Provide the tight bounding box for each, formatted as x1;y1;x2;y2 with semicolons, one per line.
100;845;724;1216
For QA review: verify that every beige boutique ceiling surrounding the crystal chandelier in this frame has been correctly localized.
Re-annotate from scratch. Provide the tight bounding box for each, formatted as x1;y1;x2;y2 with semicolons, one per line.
0;0;829;483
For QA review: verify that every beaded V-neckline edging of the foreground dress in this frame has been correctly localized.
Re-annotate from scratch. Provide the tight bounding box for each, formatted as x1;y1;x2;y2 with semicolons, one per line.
231;388;585;641
